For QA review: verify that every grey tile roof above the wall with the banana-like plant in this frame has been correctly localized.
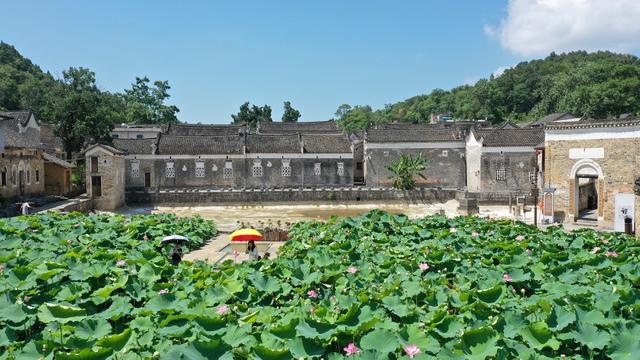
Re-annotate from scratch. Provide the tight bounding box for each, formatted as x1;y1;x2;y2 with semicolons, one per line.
365;129;464;143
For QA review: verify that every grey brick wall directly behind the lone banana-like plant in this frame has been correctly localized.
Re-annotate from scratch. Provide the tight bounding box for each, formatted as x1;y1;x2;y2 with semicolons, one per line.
364;147;466;189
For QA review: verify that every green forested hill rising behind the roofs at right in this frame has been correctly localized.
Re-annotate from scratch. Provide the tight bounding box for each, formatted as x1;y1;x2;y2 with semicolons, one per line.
336;51;640;129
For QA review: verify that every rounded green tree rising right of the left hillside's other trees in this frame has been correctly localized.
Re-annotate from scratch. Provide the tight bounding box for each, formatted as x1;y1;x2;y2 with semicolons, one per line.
124;76;180;124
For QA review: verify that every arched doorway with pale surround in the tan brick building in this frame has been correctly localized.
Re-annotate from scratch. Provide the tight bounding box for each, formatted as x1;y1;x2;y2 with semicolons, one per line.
570;159;604;222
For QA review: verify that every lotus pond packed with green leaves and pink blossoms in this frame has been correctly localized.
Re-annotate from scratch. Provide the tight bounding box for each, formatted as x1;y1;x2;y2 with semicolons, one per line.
0;211;640;359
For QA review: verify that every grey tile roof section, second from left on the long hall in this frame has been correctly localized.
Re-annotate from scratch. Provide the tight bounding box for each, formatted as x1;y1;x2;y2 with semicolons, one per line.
157;134;244;155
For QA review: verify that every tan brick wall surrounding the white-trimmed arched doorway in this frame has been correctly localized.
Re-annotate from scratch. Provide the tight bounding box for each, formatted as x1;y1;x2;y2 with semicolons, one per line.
545;138;640;227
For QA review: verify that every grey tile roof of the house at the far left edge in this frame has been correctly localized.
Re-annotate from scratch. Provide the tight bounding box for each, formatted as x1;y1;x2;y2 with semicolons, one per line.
0;111;43;149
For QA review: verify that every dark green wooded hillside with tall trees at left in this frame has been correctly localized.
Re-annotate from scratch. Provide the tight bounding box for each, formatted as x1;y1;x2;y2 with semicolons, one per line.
0;42;179;152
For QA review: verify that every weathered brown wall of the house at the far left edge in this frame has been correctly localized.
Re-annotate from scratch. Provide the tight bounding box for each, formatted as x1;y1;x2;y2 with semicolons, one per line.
0;148;44;198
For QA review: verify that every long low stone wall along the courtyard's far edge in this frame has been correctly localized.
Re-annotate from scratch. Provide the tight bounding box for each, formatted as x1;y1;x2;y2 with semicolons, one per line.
127;188;457;206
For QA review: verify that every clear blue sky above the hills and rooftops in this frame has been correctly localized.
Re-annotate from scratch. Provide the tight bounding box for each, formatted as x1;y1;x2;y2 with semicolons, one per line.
0;0;637;123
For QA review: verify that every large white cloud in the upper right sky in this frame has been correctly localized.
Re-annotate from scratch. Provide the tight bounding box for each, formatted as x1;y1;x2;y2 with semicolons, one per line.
484;0;640;56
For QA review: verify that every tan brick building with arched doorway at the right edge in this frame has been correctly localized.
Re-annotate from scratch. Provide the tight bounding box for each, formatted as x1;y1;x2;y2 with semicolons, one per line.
544;118;640;231
